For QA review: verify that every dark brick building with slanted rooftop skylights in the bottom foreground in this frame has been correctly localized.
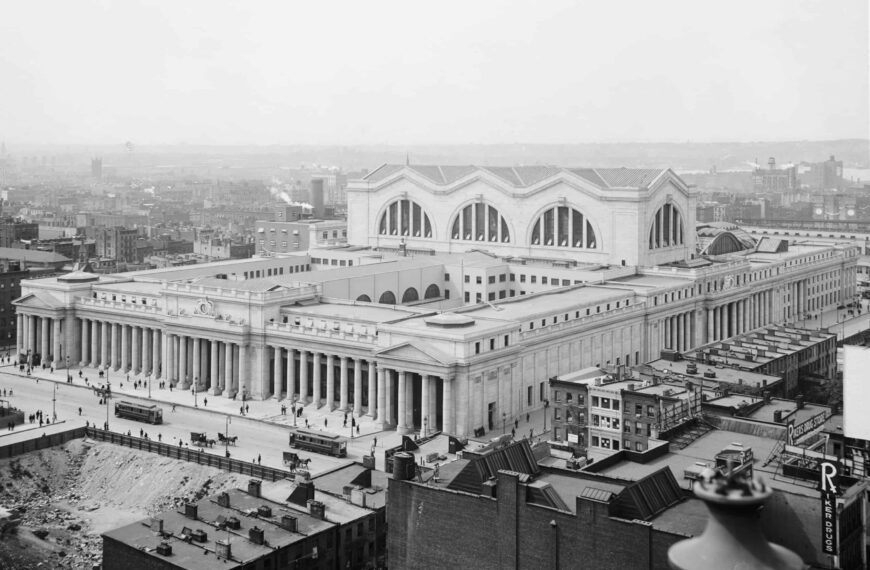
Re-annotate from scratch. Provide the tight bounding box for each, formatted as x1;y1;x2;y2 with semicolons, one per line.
387;440;687;570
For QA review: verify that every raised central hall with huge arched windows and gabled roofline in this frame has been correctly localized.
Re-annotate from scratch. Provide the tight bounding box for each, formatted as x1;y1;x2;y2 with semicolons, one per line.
347;165;697;265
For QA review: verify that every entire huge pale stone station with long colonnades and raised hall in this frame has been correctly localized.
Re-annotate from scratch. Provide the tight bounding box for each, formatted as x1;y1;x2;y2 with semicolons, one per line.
15;165;858;435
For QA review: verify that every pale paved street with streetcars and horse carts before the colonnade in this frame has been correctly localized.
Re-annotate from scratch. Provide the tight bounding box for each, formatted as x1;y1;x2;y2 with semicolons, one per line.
0;365;549;475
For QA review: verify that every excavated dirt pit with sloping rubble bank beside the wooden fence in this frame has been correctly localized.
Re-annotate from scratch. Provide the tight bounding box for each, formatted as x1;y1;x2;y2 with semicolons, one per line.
0;440;248;570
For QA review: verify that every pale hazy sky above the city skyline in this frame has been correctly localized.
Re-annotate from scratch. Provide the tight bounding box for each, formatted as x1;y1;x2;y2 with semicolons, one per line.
0;0;870;145
